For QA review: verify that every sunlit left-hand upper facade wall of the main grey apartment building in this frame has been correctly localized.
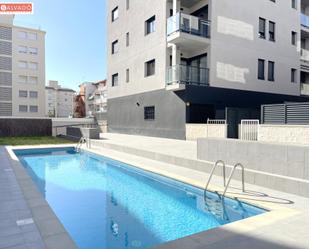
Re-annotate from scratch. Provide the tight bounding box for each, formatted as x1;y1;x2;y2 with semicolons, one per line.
107;0;167;98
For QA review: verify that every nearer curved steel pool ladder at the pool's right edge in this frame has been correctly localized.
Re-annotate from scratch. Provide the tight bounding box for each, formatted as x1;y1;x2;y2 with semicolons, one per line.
204;160;245;202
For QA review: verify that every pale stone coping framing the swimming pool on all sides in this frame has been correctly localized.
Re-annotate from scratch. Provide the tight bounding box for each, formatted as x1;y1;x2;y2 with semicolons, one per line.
5;144;300;249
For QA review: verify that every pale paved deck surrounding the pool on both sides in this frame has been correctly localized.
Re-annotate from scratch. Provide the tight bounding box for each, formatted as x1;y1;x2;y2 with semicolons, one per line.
0;134;309;249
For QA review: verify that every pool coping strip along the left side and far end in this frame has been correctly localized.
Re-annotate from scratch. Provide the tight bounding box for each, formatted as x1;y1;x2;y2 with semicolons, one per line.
4;144;78;249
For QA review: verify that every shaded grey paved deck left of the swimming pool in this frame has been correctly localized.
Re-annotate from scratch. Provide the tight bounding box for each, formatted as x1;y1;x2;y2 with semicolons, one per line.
0;145;77;249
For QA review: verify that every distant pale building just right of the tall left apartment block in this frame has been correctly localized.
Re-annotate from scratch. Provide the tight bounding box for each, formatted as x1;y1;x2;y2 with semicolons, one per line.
45;81;75;118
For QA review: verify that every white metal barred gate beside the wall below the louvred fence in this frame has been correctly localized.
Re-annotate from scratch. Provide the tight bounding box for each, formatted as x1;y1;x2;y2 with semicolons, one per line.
240;119;260;141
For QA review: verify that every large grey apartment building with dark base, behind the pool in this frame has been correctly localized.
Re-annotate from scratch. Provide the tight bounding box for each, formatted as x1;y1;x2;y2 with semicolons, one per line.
107;0;309;139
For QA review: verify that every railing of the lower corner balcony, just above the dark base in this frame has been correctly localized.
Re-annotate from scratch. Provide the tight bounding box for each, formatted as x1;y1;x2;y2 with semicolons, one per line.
166;65;209;86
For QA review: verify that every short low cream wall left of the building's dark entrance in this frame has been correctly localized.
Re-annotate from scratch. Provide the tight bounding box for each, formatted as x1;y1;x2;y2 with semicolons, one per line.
186;124;227;140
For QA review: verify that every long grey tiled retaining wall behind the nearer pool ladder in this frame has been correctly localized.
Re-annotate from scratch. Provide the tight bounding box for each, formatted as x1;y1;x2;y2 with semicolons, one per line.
197;138;309;197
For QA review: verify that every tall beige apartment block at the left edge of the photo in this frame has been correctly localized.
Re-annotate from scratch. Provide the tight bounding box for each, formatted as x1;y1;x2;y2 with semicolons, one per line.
0;15;45;117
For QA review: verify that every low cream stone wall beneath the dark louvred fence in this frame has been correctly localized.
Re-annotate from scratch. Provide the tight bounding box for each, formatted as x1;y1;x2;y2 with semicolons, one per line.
258;125;309;145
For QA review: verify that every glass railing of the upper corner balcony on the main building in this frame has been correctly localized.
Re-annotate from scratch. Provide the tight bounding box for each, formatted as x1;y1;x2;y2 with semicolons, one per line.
167;12;210;38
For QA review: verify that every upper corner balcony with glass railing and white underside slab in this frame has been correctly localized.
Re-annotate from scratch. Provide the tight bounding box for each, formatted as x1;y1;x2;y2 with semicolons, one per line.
167;12;210;49
